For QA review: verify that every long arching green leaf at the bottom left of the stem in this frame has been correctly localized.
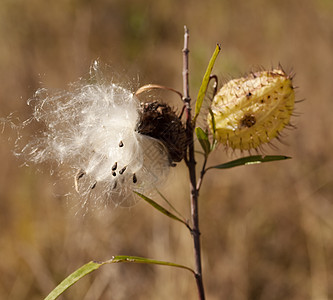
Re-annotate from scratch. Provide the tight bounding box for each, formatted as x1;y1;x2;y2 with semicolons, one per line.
44;255;195;300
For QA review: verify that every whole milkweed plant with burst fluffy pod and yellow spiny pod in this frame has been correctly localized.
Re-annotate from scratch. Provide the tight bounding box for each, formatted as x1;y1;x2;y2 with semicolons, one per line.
16;27;295;300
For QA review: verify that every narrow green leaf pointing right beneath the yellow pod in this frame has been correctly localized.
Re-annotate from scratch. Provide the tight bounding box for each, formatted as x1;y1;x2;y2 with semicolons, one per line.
207;155;291;170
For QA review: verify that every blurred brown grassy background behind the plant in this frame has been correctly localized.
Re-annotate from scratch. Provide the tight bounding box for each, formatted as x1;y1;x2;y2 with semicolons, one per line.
0;0;333;300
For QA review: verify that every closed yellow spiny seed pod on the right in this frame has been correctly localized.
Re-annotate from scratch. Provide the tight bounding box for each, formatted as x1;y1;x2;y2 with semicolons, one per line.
208;69;295;150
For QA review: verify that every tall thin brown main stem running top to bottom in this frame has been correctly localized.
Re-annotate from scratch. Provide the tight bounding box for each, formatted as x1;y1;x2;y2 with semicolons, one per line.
183;26;205;300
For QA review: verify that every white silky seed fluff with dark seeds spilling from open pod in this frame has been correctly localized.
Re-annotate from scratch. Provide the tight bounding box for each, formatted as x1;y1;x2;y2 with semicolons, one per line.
17;62;170;208
